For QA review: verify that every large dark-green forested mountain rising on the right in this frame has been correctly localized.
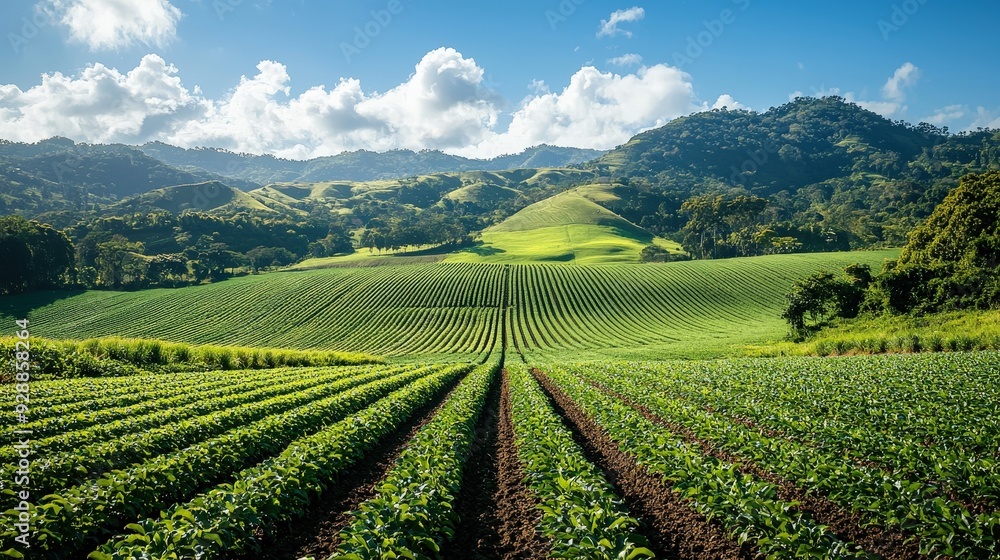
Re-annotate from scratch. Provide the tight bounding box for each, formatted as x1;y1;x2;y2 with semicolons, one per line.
588;97;1000;256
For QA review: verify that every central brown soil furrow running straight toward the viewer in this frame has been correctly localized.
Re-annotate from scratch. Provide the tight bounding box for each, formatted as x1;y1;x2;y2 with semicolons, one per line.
442;370;549;560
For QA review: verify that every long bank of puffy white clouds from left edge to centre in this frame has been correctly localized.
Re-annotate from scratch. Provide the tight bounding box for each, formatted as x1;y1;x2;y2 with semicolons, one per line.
0;49;499;158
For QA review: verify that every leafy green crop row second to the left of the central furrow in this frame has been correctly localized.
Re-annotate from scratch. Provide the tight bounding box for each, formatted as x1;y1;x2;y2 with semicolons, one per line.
90;360;469;560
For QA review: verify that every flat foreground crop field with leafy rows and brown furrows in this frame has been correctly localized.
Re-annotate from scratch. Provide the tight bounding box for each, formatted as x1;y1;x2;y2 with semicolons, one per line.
0;348;1000;559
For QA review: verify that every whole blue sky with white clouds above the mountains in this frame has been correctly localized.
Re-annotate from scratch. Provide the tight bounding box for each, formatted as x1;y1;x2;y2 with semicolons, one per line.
0;0;1000;158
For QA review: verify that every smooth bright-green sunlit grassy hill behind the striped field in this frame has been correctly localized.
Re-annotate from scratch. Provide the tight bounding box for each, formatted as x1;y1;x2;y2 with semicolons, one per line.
446;188;681;264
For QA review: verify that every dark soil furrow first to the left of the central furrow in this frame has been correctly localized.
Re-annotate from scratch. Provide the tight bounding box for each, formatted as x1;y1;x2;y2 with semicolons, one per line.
254;376;457;560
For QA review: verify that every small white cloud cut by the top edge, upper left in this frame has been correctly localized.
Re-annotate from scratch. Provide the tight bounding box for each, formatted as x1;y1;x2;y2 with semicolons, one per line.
39;0;182;51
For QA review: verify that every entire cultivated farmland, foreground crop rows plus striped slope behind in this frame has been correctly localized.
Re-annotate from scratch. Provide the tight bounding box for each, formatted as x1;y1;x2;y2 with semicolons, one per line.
0;252;1000;560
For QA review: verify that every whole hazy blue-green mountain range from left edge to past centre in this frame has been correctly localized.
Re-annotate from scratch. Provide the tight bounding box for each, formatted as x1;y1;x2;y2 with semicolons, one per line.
0;138;603;219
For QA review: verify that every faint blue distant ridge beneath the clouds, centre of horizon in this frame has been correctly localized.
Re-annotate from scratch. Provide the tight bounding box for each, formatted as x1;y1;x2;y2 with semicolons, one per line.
140;142;604;184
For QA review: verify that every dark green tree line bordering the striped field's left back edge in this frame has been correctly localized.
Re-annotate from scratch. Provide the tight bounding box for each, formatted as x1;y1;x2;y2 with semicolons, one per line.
0;207;490;294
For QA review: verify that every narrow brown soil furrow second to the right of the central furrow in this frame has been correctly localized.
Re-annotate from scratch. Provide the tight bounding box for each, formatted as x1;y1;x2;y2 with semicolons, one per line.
589;382;923;560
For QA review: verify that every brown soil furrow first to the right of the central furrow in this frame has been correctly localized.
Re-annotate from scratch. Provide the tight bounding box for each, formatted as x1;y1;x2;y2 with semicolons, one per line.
532;369;758;560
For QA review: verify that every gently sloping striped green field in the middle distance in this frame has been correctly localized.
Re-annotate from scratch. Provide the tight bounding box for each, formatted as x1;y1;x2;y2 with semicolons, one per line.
0;251;897;358
